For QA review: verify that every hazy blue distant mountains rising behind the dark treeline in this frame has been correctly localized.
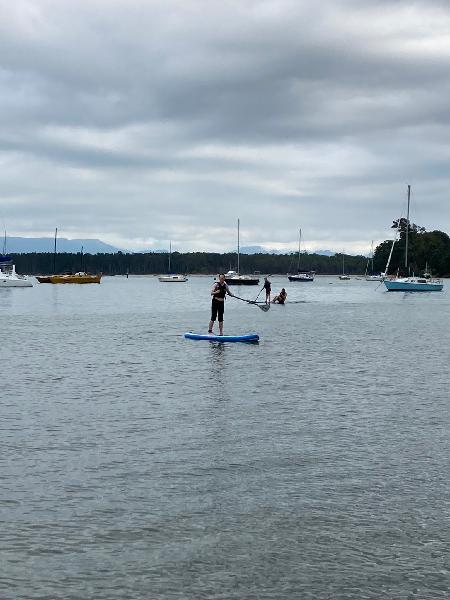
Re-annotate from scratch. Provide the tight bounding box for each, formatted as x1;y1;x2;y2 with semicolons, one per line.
5;237;335;256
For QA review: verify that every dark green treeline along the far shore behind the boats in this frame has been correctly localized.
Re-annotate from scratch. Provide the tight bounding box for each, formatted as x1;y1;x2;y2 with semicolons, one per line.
8;219;450;277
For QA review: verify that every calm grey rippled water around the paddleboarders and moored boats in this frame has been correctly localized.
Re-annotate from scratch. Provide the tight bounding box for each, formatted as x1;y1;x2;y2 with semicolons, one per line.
0;277;450;600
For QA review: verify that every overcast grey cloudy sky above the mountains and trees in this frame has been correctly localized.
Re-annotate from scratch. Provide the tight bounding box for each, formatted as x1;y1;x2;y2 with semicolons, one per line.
0;0;450;253
